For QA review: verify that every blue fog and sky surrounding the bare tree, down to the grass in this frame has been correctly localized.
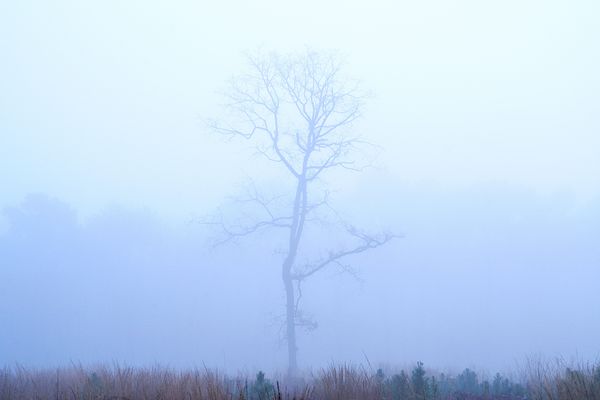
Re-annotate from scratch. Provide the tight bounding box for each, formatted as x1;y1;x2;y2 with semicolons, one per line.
0;0;600;371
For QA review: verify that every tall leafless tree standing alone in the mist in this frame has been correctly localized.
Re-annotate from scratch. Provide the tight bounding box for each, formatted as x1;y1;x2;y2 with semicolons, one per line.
210;51;395;377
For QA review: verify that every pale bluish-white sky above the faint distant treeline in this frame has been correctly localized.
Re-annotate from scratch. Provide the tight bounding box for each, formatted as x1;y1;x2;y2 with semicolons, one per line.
0;0;600;222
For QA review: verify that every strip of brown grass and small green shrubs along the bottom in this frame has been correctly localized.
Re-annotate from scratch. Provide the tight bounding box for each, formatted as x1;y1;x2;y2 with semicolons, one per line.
0;363;600;400
